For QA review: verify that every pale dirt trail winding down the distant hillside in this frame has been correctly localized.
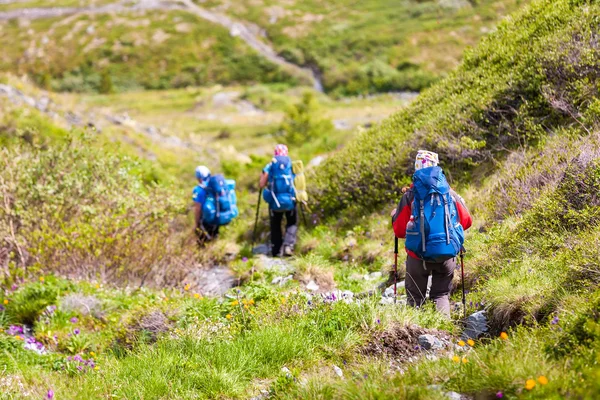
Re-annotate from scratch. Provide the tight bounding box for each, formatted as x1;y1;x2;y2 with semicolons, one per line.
0;0;323;92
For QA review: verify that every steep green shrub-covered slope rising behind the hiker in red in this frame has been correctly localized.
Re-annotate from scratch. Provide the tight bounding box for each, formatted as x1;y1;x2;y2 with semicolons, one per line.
313;1;600;219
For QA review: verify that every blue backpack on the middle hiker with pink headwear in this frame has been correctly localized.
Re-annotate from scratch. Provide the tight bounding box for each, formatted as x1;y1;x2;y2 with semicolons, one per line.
263;156;296;211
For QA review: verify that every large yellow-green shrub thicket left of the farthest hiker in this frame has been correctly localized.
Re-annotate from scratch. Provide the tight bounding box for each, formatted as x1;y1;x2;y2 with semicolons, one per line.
0;134;195;284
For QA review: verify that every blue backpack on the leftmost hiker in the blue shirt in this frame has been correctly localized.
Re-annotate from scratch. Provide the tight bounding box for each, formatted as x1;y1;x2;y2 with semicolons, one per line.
202;175;239;225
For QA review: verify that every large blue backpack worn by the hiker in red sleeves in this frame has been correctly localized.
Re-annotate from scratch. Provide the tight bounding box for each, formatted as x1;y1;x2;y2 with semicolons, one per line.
405;167;464;262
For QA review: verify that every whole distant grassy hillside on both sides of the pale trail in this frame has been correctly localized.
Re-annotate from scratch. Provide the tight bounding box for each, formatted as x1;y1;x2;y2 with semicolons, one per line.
0;0;521;95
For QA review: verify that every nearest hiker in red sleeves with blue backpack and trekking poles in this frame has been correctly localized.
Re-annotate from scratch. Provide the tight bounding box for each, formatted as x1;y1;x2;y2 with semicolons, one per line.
391;150;473;317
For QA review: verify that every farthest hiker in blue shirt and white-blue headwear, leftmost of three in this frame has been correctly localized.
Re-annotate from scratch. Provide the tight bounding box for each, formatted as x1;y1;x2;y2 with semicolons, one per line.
192;165;239;245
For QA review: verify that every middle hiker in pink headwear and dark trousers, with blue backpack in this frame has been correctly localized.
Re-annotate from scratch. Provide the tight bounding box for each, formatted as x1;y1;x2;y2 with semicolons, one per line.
260;144;298;257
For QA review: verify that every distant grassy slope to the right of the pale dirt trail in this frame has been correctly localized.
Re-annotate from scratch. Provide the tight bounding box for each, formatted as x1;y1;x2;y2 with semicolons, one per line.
219;0;527;95
